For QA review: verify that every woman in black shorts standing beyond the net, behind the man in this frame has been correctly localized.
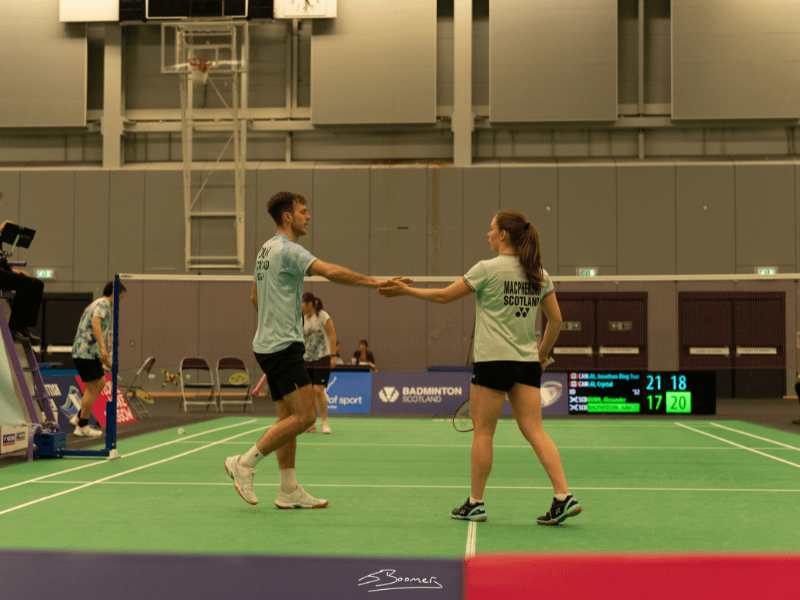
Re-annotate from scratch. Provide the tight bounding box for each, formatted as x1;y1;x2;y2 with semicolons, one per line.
302;292;337;433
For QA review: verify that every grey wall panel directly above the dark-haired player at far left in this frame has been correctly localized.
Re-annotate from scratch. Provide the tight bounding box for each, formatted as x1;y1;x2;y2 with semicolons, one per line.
73;171;111;281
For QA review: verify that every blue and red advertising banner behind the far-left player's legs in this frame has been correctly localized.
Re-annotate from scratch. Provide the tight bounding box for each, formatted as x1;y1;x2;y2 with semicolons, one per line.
42;370;136;432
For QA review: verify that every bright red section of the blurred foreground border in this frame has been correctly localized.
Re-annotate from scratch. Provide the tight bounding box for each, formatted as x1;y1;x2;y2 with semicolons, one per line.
464;553;800;600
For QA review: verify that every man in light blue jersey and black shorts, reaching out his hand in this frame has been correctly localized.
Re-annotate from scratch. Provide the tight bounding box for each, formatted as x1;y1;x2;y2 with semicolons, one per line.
225;192;410;508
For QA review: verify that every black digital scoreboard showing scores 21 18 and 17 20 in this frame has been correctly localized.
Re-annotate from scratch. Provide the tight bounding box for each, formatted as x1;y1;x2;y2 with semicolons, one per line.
567;371;717;415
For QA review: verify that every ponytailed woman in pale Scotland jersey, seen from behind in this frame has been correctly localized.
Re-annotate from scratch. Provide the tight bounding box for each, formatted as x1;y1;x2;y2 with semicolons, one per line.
380;210;581;525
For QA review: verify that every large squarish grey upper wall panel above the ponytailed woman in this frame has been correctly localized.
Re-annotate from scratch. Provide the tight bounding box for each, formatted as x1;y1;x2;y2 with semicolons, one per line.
489;0;618;122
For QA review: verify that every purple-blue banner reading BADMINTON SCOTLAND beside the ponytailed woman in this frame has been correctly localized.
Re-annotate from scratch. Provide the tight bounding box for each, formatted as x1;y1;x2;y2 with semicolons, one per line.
372;372;472;415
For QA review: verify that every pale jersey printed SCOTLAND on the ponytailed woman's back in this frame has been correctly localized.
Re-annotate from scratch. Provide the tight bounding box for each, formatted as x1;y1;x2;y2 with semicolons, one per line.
464;254;555;362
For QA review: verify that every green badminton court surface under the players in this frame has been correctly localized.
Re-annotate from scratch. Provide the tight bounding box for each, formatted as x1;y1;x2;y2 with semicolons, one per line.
0;417;800;558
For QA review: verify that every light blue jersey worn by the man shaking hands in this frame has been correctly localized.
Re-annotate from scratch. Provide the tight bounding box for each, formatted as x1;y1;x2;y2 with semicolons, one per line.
253;233;317;354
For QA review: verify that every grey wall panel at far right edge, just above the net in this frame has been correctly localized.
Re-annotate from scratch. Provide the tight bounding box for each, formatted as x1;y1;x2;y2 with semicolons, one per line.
734;161;797;273
